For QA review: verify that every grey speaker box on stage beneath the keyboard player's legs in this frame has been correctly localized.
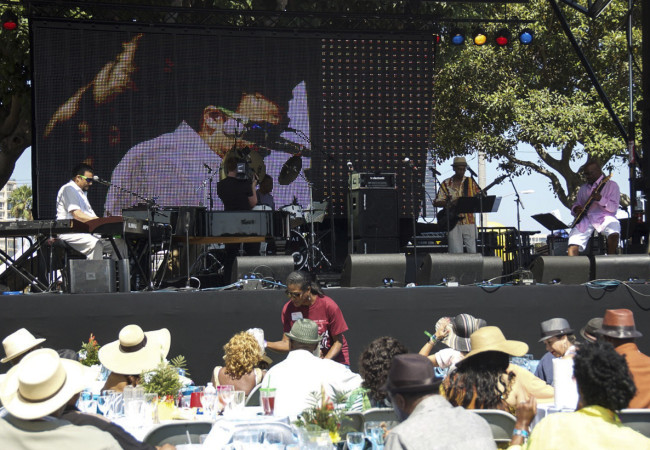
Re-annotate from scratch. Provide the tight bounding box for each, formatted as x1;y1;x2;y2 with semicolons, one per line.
68;259;116;294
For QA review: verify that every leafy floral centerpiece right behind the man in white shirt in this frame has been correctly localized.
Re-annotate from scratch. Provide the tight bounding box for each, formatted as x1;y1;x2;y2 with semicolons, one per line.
295;386;348;442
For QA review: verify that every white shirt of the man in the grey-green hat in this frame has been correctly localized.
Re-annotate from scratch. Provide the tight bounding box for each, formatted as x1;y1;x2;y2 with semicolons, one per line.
262;350;362;418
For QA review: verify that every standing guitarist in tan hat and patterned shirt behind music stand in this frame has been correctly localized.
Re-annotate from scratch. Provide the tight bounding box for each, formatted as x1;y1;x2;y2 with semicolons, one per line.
433;156;480;253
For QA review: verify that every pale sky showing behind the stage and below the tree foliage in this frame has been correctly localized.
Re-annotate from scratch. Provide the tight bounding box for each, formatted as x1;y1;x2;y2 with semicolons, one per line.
11;145;630;234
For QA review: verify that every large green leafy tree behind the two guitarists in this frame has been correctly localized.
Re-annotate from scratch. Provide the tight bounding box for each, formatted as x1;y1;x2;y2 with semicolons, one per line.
432;0;641;207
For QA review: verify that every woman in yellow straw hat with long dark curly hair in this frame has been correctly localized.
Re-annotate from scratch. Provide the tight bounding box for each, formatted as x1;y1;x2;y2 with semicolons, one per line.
441;326;554;412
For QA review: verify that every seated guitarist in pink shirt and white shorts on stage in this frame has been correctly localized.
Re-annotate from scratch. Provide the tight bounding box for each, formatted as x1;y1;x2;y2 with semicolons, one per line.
568;161;621;256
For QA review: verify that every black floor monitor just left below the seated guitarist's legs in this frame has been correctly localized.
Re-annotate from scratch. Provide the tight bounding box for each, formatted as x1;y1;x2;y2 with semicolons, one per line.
530;256;591;284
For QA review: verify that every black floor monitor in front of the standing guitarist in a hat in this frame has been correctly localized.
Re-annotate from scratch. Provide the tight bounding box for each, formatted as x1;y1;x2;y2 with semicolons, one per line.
416;253;484;285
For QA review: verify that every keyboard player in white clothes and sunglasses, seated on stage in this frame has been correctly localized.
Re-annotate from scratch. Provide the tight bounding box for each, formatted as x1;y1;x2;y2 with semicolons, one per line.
56;163;128;259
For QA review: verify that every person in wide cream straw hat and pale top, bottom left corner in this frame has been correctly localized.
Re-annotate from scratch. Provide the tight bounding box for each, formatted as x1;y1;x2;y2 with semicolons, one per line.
0;349;121;450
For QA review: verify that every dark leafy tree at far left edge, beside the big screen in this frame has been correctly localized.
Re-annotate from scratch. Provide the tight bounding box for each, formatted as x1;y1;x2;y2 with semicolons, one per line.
0;3;32;190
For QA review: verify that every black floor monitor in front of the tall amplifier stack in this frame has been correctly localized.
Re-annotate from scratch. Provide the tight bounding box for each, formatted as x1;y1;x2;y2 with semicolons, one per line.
341;253;406;287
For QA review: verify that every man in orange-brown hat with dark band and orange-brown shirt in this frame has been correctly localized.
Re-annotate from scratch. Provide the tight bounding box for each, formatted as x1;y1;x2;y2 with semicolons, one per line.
596;309;650;408
